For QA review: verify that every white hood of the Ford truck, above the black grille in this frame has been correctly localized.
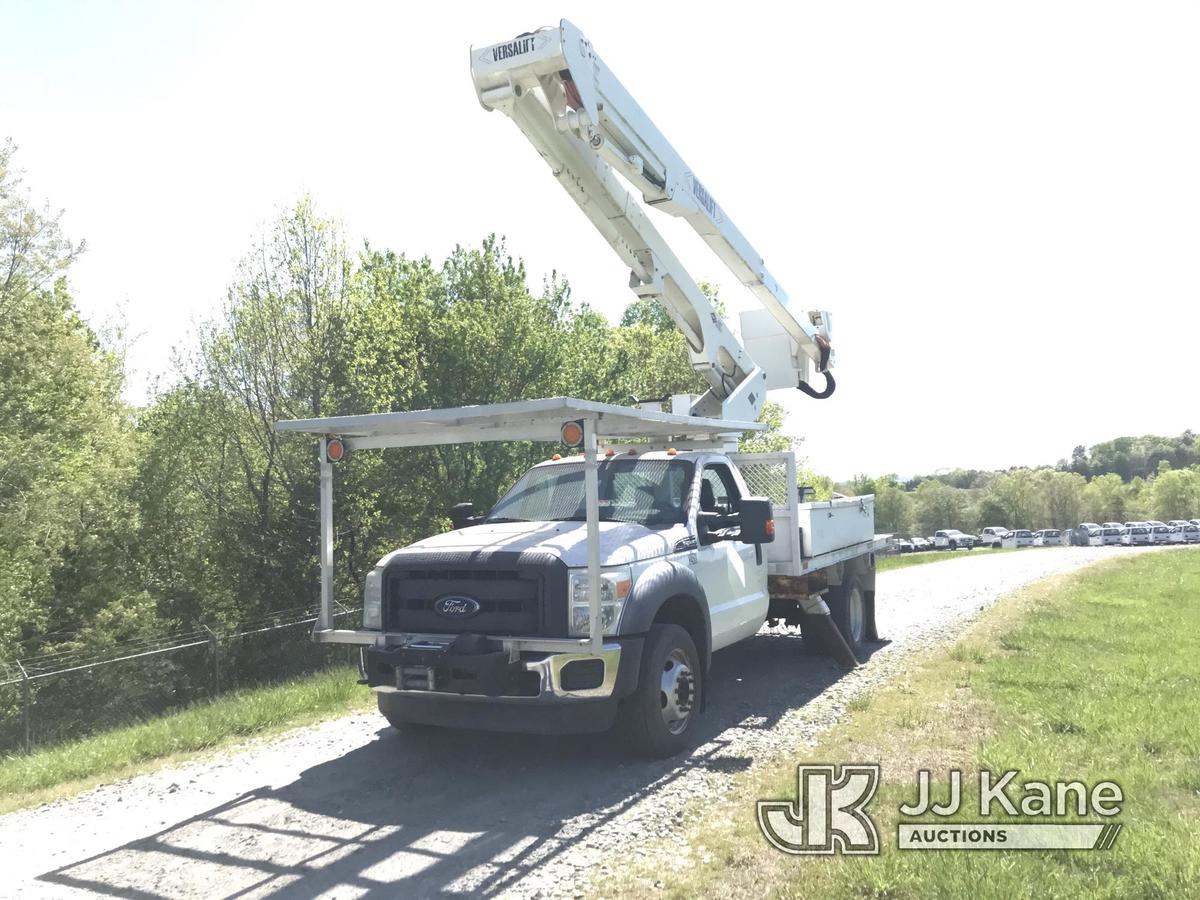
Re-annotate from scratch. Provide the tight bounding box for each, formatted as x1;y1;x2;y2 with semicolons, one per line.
379;522;688;569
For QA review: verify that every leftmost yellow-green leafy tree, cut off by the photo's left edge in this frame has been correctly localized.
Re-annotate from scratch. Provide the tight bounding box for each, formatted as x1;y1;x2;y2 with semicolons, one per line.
0;142;139;672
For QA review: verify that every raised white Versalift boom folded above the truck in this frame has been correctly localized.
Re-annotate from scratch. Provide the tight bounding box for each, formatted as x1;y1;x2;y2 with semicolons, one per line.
470;19;833;420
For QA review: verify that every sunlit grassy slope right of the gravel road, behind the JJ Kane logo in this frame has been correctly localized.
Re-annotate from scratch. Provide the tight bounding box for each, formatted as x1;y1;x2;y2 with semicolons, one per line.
619;551;1200;900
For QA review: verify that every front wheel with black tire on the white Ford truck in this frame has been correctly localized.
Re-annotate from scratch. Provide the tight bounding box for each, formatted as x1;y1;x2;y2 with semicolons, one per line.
620;625;704;760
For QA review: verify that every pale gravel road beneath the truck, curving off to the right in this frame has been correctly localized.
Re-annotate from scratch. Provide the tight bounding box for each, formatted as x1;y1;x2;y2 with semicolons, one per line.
0;547;1140;899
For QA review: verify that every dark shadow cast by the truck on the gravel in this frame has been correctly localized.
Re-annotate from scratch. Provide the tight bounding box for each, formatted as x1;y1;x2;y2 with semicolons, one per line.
38;632;888;899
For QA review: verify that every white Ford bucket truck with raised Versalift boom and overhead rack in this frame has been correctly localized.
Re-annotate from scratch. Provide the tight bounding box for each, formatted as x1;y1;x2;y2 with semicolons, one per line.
276;20;886;756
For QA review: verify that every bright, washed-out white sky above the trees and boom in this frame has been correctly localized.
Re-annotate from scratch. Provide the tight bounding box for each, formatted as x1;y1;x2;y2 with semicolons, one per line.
0;1;1200;476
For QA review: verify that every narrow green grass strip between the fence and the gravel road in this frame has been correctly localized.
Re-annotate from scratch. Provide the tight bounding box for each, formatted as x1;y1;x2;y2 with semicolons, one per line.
0;667;374;811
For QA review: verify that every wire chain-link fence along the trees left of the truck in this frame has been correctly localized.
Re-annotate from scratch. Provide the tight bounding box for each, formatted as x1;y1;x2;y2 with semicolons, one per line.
0;607;356;752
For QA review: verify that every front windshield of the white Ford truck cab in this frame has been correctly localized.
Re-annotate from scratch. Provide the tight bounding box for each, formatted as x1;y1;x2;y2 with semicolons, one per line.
485;456;695;528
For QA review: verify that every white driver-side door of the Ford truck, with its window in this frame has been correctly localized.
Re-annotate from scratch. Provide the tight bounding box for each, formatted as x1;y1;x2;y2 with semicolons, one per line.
696;462;767;650
